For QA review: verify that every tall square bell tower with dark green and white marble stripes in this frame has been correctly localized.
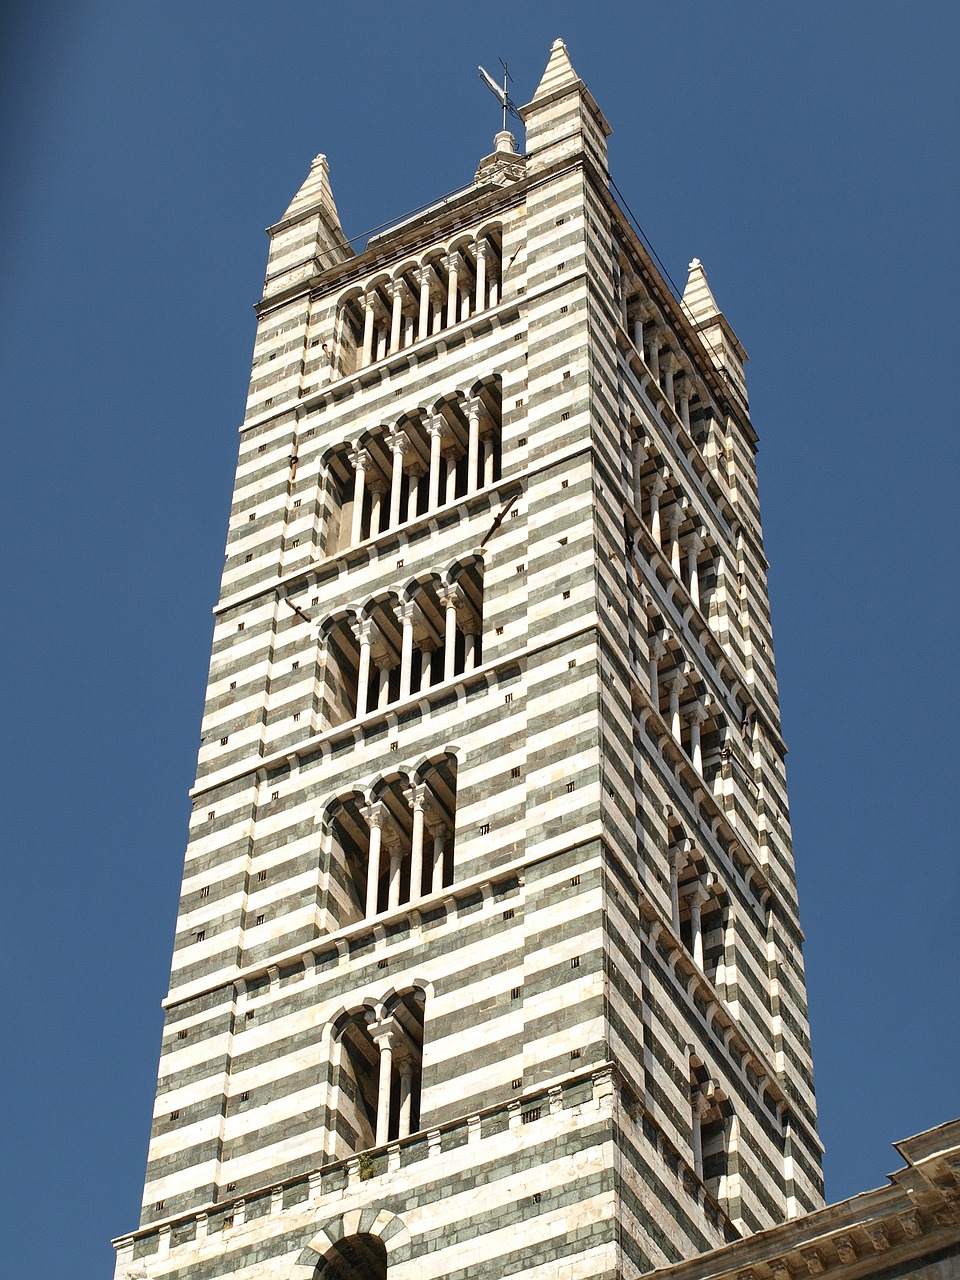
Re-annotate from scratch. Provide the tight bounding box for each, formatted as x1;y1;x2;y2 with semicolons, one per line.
116;42;822;1280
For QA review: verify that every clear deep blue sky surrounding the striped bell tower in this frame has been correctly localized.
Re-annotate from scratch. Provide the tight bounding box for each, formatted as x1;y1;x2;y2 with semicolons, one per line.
0;0;960;1280
